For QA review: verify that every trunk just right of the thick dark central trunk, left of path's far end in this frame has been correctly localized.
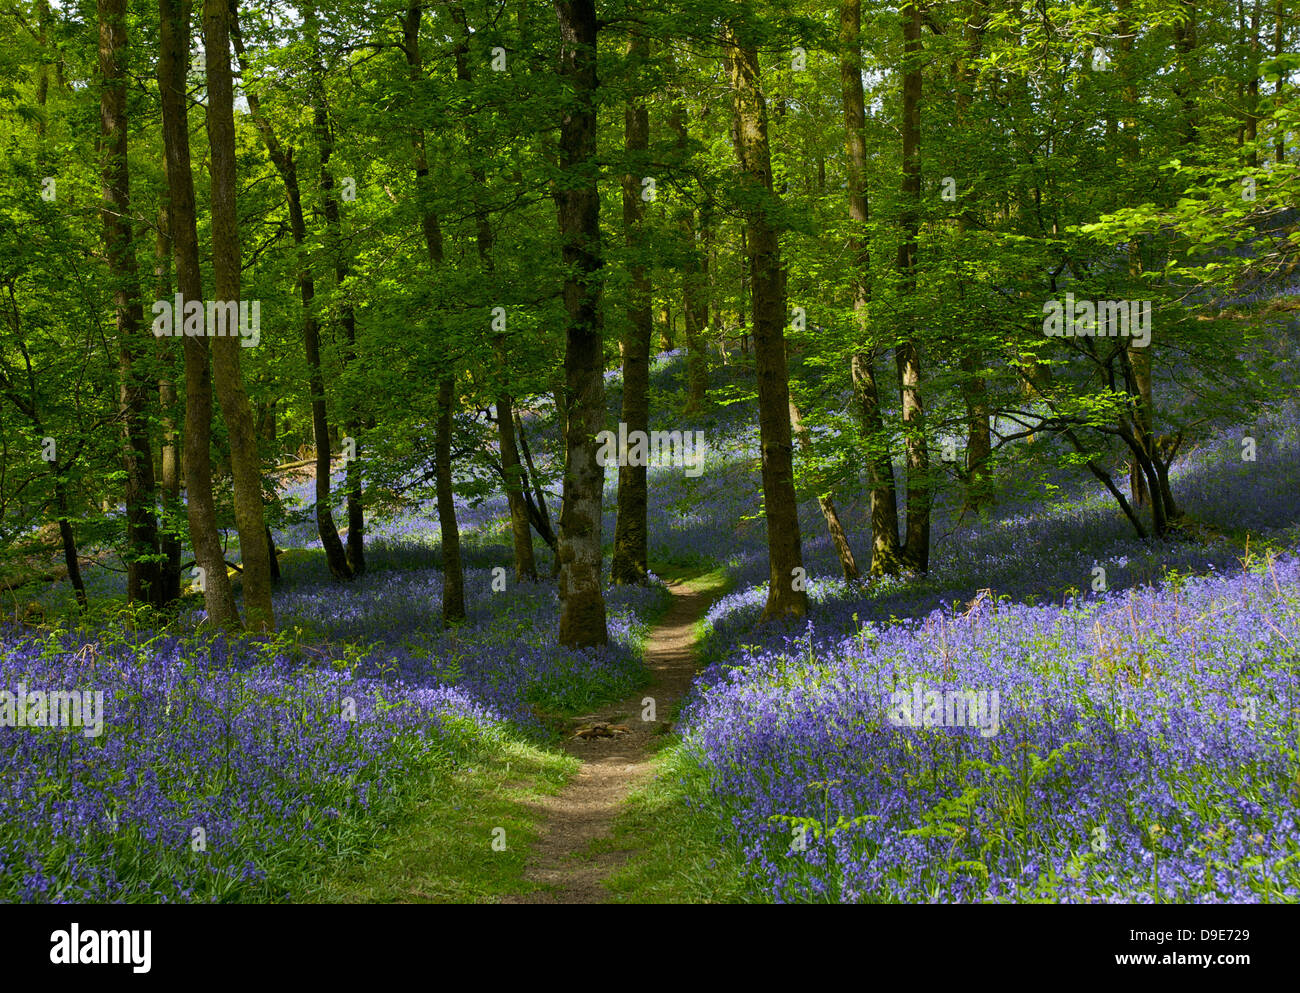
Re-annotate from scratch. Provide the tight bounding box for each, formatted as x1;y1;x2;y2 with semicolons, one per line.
610;30;654;584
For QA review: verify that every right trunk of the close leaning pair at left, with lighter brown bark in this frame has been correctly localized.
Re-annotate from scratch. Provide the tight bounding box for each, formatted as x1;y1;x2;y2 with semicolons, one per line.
203;0;276;630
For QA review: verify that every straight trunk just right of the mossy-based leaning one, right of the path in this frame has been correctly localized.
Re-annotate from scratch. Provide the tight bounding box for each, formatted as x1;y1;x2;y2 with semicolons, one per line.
894;0;931;573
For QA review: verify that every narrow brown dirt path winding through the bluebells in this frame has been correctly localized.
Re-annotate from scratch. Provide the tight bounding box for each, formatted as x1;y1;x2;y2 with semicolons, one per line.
502;582;720;903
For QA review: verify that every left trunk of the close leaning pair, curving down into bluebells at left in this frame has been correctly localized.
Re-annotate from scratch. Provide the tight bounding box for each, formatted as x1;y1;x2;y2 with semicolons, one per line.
159;0;239;628
